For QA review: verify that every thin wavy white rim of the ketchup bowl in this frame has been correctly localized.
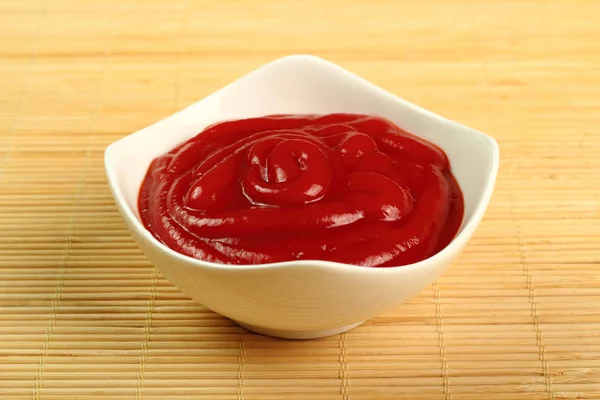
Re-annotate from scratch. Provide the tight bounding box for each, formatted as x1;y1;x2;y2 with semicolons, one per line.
104;54;500;274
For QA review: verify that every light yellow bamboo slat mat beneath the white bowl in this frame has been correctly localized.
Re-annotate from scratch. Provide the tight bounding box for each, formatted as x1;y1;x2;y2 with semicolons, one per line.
0;0;600;400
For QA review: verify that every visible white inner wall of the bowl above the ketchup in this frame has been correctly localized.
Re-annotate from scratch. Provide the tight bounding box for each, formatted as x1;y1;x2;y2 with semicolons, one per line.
105;56;499;250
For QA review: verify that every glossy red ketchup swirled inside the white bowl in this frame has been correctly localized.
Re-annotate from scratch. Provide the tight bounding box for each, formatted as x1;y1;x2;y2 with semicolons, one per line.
139;114;464;267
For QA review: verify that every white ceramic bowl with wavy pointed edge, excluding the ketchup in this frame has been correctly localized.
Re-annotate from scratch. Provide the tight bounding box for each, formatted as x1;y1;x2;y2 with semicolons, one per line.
104;55;500;339
